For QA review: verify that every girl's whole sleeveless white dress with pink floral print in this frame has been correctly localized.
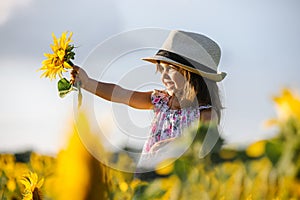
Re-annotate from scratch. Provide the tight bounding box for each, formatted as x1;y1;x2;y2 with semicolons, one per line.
134;90;212;177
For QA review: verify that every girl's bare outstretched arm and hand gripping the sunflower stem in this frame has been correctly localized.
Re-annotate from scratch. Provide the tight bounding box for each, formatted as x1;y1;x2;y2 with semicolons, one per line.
71;66;153;109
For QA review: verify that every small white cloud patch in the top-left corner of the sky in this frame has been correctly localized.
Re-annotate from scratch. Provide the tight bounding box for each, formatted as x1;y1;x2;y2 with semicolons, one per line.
0;0;32;25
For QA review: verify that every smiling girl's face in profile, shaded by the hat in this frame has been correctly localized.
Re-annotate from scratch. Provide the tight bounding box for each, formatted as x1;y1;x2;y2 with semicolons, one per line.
156;62;185;96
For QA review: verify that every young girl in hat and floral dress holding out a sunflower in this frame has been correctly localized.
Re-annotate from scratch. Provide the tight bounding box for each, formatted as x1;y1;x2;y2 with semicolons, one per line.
71;30;226;175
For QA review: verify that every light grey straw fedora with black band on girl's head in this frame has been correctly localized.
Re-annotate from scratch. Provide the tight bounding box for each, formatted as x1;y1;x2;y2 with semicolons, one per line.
142;30;226;81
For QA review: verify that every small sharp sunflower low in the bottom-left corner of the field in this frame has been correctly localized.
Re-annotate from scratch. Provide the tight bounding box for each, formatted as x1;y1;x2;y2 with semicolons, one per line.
20;172;44;200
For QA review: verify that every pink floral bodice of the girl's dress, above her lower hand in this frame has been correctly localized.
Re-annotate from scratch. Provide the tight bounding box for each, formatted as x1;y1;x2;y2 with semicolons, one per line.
143;90;211;153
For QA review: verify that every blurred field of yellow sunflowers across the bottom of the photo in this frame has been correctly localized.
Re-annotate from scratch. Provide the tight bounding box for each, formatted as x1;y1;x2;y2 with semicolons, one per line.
0;89;300;200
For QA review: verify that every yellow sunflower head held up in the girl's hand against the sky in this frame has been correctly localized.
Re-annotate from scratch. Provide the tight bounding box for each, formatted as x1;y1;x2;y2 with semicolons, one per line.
39;32;75;80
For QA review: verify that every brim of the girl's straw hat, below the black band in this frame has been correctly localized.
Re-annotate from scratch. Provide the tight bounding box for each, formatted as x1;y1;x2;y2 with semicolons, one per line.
142;55;227;82
